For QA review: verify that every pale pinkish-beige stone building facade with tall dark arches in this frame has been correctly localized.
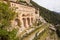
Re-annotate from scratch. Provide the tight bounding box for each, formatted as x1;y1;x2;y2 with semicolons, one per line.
10;0;39;28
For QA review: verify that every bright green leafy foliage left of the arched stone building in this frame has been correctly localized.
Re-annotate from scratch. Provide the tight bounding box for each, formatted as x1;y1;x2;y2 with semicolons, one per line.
0;1;17;40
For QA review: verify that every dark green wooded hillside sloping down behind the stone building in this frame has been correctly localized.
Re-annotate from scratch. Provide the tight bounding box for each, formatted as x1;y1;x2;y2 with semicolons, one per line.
31;1;60;37
